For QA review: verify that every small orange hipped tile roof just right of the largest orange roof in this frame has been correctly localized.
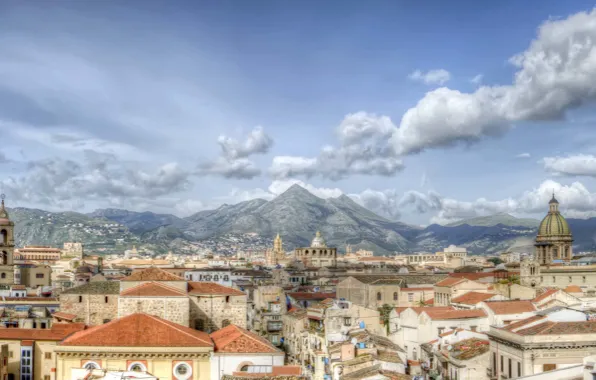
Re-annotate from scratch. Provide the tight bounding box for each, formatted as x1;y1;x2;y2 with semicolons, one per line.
210;325;283;354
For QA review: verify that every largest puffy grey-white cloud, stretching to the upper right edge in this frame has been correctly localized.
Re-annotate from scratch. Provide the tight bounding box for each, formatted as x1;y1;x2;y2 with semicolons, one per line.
393;9;596;154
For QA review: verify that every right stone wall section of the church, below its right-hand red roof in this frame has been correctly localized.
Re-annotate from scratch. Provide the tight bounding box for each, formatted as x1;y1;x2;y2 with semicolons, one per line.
190;295;248;331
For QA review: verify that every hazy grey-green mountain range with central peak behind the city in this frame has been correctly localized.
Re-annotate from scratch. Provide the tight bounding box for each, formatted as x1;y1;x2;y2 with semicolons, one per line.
10;185;596;255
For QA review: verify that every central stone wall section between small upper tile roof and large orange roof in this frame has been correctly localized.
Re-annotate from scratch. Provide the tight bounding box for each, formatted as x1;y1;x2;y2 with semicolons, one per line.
118;296;190;327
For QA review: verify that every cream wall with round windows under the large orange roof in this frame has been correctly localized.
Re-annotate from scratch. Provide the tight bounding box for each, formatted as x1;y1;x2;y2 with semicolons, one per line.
56;354;211;380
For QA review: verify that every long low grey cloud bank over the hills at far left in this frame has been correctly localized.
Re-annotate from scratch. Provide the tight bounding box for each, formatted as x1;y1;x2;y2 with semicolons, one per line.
0;151;190;209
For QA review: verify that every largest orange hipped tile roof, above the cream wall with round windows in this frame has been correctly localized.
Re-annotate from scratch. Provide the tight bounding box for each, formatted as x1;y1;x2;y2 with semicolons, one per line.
60;313;213;347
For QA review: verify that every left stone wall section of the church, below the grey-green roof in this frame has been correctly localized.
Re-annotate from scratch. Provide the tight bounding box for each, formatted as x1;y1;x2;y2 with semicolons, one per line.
60;294;118;326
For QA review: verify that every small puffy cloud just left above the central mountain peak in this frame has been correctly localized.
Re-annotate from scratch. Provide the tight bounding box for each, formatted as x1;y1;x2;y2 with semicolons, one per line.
196;127;273;179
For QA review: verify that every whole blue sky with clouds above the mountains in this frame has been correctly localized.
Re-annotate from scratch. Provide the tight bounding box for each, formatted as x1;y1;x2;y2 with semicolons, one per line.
0;1;596;224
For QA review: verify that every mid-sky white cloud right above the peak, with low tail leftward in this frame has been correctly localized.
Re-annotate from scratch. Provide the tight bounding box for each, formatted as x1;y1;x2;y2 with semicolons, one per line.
269;112;403;180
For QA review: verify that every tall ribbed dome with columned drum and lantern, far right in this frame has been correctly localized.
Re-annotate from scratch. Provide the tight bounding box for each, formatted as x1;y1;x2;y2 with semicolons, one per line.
534;194;573;265
